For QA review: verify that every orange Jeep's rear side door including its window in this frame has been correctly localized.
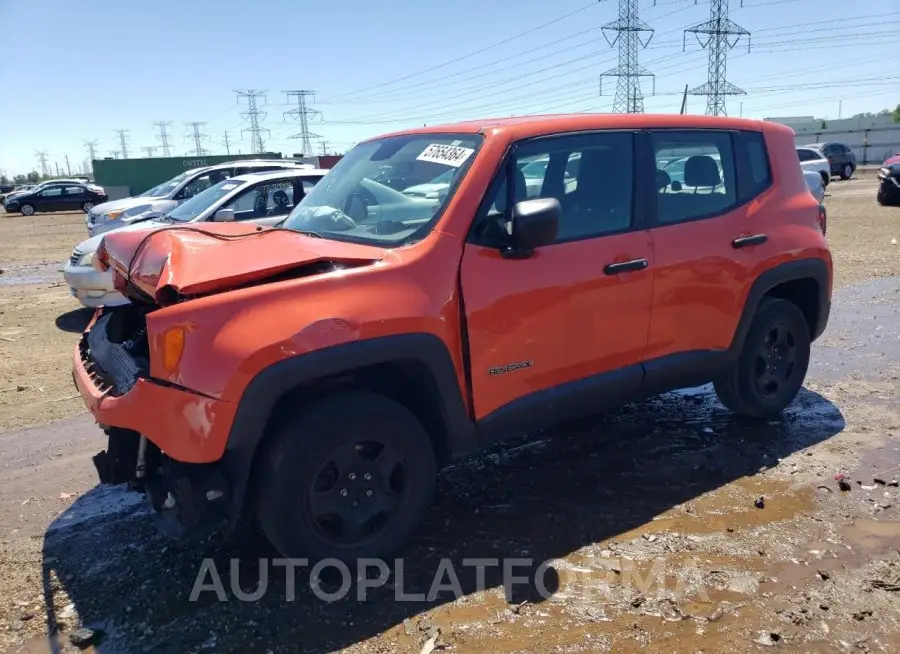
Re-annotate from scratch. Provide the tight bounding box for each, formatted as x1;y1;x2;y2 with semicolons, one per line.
645;129;771;388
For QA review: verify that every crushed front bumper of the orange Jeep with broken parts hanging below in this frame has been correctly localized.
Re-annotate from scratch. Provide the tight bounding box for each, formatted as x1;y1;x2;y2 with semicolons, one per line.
72;309;234;538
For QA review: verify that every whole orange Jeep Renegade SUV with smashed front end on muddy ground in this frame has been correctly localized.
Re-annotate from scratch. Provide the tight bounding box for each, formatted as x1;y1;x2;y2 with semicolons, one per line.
74;115;832;560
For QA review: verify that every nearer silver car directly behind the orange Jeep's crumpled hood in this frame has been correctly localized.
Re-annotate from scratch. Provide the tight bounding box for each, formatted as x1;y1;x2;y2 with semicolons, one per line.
63;168;328;308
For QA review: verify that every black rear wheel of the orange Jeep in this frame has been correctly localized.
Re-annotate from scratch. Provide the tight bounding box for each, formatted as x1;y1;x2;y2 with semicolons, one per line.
713;297;811;418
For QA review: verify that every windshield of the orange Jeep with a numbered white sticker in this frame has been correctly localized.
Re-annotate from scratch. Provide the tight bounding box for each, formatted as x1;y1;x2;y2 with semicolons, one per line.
282;134;483;246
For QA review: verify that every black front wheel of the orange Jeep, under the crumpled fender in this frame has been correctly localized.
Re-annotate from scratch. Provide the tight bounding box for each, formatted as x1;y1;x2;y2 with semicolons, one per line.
254;392;437;563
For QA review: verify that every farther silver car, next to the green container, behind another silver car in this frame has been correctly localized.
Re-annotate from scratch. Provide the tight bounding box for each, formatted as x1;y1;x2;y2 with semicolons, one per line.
85;159;313;236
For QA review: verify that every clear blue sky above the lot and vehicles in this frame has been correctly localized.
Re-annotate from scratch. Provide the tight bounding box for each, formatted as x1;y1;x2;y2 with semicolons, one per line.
0;0;900;175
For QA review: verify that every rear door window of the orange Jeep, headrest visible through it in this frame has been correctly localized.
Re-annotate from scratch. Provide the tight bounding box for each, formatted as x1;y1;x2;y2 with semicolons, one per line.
650;130;738;225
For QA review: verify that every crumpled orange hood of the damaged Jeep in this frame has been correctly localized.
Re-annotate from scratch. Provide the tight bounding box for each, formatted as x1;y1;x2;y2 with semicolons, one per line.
97;223;384;304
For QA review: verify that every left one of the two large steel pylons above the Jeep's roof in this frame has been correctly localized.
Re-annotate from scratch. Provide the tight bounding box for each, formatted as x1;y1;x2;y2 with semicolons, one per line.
600;0;655;114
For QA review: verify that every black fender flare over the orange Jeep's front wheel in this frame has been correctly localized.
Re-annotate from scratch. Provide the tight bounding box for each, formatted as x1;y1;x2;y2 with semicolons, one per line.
222;333;477;527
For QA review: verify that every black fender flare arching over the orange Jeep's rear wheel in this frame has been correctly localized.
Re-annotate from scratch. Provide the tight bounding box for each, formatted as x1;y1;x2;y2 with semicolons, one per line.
729;258;831;356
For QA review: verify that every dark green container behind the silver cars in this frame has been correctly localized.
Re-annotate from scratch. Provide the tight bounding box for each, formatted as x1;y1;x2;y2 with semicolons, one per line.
93;152;282;200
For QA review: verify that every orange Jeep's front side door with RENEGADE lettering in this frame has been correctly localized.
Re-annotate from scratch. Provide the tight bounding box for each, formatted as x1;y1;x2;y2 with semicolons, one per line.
461;132;652;426
